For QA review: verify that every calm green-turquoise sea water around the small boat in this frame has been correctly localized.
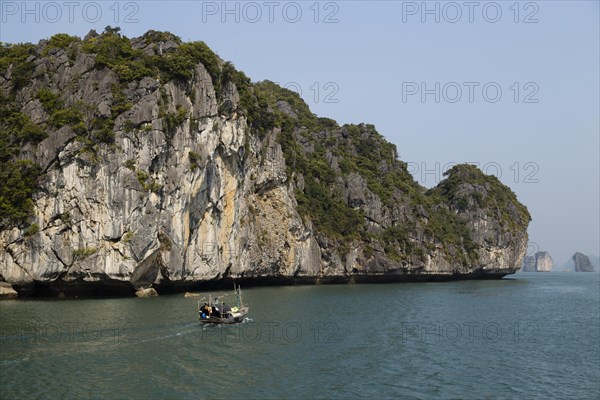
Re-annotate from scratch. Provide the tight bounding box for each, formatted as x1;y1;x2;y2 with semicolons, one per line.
0;273;600;399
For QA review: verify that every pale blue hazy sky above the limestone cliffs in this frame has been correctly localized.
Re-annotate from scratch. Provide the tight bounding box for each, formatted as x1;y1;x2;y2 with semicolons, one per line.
0;0;600;264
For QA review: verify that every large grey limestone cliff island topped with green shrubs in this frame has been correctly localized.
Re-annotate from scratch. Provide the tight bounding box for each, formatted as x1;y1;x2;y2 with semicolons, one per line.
0;31;530;294
